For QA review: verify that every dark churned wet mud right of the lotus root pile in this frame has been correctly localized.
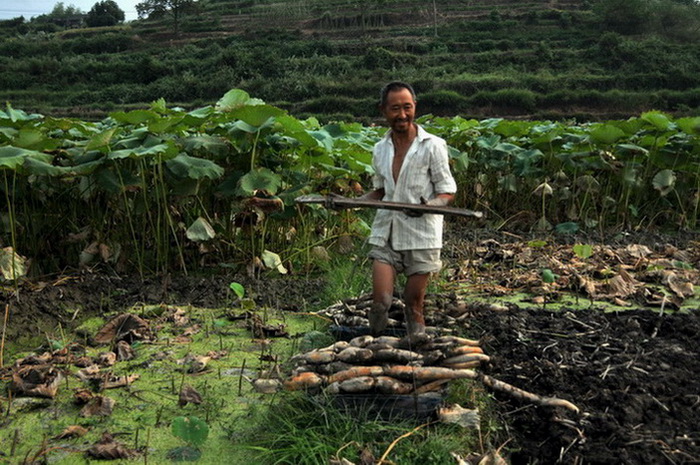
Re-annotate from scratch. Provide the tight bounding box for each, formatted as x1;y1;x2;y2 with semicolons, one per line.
470;310;700;464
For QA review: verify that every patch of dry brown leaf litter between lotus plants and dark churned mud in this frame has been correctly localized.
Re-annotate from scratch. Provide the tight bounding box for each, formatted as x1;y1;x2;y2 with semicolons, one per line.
450;239;700;309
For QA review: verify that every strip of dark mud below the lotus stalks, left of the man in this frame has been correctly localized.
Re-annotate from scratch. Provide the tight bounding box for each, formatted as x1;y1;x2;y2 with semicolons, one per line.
0;273;323;341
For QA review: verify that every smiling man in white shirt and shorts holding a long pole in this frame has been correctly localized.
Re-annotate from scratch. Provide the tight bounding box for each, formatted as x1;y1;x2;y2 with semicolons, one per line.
362;81;457;337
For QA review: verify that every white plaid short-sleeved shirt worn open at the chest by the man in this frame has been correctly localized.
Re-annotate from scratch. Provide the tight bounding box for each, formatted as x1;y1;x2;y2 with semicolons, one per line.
369;126;457;250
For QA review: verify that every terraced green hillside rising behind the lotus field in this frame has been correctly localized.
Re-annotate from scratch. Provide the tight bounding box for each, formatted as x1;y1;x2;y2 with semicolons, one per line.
0;0;700;119
